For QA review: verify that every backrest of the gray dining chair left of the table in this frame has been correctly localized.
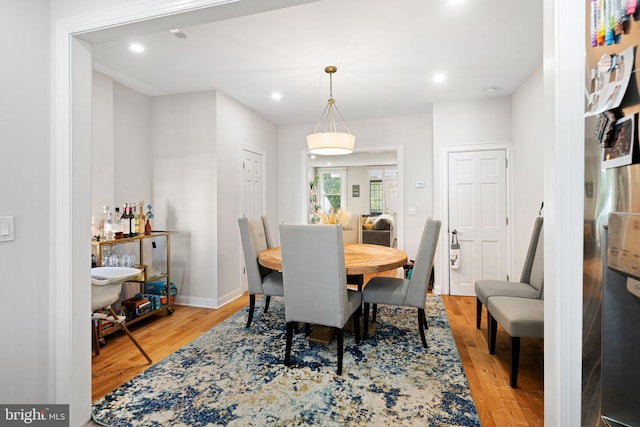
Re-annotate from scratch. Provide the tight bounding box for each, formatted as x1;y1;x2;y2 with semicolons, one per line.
238;216;271;294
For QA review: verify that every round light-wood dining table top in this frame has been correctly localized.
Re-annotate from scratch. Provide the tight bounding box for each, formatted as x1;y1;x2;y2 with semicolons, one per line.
258;243;407;275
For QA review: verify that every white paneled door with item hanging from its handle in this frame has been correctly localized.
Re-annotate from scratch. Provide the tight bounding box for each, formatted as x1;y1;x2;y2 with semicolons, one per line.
449;150;508;295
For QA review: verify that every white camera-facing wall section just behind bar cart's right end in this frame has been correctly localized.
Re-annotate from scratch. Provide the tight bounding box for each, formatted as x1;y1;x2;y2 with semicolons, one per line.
151;91;218;307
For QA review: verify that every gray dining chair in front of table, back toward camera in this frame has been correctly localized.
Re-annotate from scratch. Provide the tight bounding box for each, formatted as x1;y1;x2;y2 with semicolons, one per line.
280;224;362;375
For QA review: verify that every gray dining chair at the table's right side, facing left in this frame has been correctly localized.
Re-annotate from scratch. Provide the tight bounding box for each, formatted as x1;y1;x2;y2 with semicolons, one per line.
362;218;440;348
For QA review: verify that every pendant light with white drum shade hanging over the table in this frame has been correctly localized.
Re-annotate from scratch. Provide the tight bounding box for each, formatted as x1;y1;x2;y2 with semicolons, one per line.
307;65;356;156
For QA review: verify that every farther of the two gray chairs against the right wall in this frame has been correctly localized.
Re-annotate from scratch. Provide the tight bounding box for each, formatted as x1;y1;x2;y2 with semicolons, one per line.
474;216;544;329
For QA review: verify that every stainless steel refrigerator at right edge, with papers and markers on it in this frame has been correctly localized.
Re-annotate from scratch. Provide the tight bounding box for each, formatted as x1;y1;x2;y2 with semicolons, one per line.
582;5;640;426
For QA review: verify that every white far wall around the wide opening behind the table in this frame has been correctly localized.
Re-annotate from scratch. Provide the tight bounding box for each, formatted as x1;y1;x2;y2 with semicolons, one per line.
278;113;434;257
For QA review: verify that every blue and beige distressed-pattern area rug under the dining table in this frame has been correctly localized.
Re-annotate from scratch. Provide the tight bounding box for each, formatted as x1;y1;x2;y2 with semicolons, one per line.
93;295;480;426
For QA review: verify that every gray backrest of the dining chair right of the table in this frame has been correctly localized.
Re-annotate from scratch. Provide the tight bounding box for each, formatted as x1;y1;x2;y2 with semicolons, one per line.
405;218;440;308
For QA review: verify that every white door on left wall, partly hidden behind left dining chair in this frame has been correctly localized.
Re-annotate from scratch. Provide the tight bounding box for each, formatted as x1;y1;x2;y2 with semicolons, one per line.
240;150;264;291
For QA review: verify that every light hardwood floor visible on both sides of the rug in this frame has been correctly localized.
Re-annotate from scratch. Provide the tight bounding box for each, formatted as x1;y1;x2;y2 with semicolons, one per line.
92;288;544;427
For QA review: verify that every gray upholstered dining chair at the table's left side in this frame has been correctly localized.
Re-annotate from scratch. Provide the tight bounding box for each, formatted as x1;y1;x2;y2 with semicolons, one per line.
238;216;284;328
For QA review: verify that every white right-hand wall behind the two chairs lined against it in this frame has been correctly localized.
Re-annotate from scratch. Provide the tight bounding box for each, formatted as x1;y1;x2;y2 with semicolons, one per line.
511;65;544;280
